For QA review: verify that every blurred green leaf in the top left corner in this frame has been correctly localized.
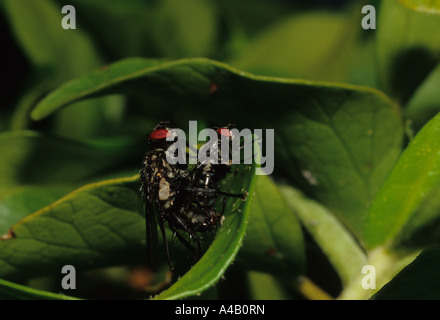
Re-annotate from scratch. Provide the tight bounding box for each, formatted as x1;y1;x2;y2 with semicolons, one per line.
4;0;99;71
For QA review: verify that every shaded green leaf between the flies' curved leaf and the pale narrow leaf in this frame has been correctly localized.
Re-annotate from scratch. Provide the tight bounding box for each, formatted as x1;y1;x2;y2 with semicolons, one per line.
237;176;305;277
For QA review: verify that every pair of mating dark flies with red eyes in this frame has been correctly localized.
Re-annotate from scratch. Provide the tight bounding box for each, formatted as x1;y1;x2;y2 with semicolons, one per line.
140;123;246;269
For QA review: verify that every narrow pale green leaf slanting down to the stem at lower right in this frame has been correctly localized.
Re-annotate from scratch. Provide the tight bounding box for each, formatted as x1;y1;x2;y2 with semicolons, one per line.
280;186;367;285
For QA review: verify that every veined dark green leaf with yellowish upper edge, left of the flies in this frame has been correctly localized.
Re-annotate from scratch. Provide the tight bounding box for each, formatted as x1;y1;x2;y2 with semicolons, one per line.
0;176;145;280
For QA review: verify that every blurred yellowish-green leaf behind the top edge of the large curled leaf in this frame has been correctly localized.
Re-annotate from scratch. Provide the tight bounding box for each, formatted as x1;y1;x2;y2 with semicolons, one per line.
231;11;357;81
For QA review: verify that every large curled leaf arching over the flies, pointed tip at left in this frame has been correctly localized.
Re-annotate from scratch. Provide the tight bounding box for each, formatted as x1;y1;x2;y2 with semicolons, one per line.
32;59;403;242
